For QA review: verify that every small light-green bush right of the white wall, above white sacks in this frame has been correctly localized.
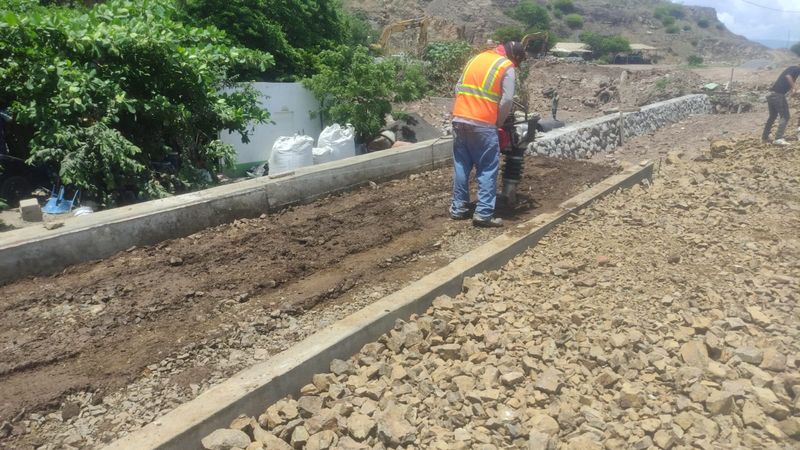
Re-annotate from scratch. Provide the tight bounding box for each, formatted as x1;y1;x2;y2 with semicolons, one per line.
303;46;427;141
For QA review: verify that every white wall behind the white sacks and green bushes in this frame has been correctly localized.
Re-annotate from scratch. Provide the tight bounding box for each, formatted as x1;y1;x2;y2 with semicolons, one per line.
220;82;322;174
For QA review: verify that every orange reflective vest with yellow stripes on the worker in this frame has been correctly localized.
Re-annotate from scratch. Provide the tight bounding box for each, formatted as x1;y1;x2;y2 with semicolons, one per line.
453;50;513;124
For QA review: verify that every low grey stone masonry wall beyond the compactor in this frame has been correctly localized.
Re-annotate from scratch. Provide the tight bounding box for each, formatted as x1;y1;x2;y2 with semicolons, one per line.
528;94;711;159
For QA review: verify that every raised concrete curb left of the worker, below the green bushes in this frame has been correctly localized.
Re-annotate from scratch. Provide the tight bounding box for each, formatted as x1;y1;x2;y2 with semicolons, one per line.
0;138;453;283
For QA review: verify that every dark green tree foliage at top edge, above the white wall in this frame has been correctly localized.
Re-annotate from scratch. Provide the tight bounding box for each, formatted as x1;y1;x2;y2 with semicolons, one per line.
180;0;346;80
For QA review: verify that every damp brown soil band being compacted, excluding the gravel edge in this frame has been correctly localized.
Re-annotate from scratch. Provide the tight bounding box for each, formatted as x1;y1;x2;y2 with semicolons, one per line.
0;157;614;423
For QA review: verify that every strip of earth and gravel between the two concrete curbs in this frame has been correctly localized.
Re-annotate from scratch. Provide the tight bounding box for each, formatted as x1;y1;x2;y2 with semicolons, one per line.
0;157;615;448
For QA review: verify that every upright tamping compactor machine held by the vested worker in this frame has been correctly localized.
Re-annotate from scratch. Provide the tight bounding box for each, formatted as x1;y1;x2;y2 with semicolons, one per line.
497;101;543;208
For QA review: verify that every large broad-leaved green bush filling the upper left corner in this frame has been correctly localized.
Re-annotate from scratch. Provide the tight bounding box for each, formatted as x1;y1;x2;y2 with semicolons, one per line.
0;0;272;204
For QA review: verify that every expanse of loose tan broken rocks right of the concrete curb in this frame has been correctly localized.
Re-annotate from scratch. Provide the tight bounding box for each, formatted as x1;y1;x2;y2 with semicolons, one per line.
202;139;800;450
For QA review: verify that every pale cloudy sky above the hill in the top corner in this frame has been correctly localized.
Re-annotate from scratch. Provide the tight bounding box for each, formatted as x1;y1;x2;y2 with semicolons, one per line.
673;0;800;42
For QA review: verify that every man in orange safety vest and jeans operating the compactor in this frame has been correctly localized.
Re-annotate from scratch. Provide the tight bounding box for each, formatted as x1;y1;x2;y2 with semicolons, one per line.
450;41;526;227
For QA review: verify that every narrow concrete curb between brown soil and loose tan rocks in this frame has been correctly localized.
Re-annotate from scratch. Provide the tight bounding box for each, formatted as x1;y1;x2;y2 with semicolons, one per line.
106;163;653;450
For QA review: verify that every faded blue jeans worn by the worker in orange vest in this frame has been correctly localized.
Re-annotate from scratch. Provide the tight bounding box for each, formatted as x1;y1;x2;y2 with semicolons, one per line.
450;123;500;220
